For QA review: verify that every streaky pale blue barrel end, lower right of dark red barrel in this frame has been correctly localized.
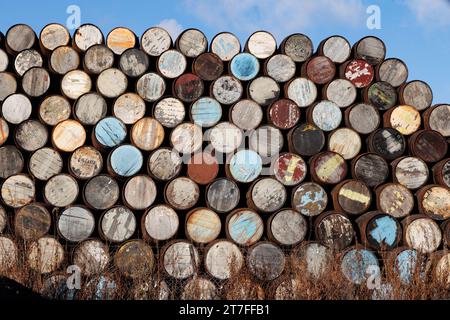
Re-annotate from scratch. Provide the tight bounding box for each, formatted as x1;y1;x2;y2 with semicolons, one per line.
189;97;222;128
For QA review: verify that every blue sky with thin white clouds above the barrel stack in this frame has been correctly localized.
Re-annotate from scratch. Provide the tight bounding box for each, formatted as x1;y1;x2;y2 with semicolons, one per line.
0;0;450;103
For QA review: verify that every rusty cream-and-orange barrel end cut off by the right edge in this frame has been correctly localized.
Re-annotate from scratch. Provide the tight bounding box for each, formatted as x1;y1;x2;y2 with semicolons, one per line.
416;185;450;220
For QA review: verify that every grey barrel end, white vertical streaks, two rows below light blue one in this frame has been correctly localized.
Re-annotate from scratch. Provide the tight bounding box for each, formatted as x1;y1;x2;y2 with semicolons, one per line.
99;206;137;243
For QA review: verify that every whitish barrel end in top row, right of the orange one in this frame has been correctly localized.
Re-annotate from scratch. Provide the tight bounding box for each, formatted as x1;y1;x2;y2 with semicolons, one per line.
140;27;172;57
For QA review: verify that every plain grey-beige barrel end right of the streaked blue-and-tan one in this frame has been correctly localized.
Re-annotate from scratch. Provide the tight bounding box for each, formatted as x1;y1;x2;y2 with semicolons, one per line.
267;209;308;246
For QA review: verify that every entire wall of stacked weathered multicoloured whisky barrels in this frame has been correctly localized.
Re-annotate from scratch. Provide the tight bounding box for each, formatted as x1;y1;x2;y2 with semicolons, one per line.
0;24;450;299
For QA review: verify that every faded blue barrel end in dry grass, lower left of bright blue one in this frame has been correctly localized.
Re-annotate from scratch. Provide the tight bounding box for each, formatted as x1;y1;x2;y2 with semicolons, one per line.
341;246;379;285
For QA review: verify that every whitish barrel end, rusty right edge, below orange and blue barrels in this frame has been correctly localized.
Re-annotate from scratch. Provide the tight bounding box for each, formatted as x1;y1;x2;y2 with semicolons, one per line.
205;240;244;280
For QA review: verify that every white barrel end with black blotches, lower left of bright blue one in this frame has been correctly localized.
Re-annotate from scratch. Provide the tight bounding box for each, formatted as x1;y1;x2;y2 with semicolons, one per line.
210;75;244;105
